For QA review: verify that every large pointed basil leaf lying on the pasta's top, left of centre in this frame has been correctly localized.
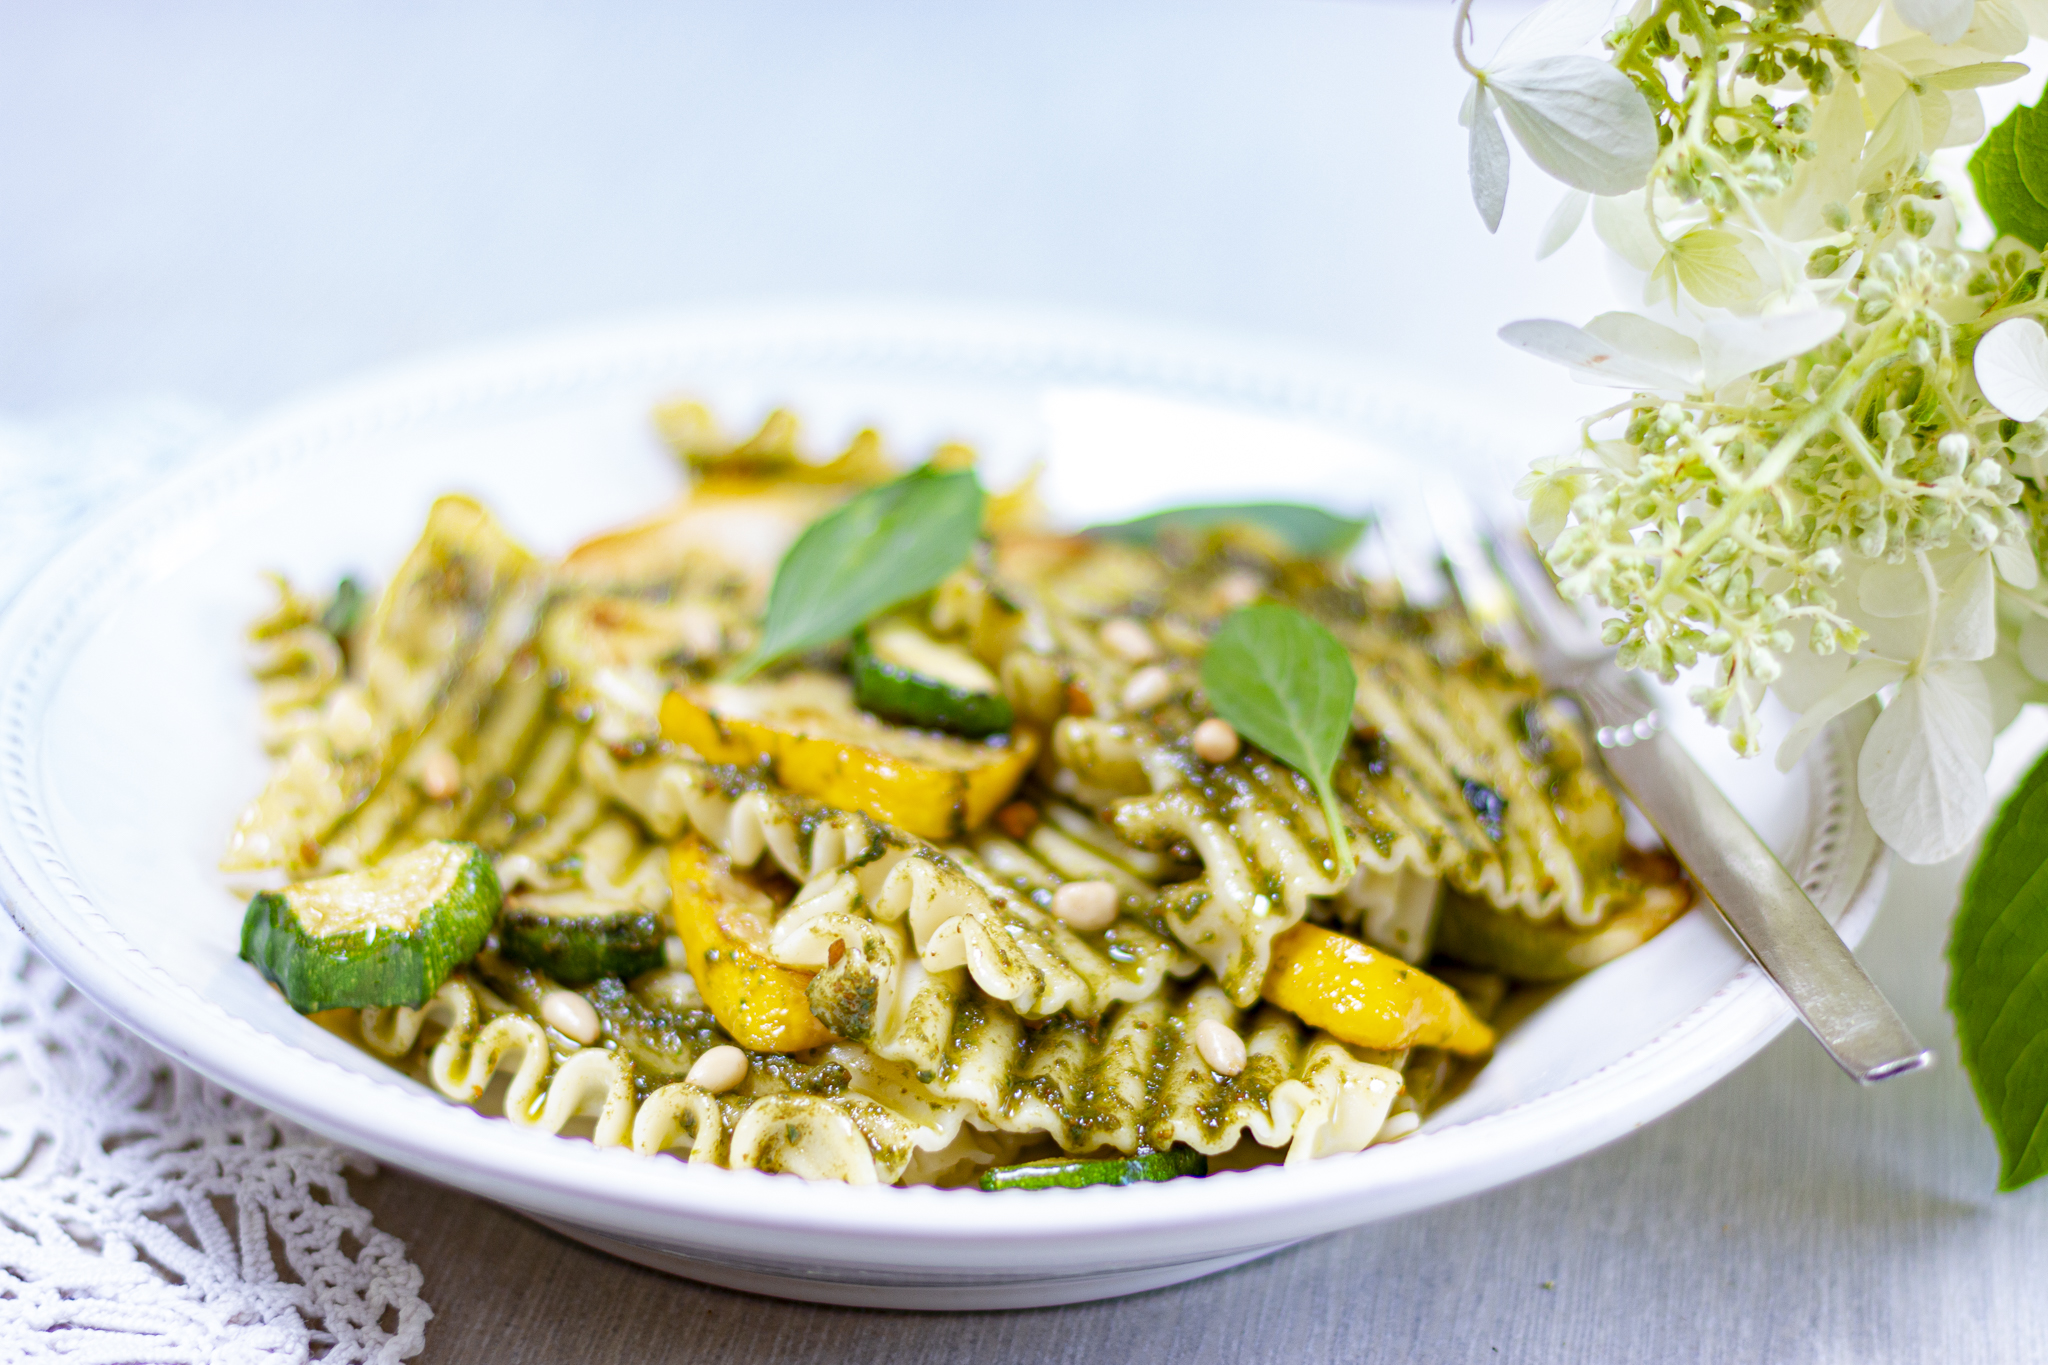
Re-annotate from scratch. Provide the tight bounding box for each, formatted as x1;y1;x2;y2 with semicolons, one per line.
733;467;983;677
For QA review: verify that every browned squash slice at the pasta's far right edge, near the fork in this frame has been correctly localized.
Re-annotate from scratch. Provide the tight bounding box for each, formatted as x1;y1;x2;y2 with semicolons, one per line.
1436;855;1692;980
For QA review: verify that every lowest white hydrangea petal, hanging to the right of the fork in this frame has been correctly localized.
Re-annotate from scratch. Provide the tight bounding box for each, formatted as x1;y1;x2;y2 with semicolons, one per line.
1855;663;1991;864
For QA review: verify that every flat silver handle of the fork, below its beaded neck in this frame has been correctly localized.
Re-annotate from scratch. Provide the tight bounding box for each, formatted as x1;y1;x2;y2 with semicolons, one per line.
1595;732;1933;1085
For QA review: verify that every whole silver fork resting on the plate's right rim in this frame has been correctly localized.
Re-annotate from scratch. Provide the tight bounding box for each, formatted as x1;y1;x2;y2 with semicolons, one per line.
1430;497;1933;1085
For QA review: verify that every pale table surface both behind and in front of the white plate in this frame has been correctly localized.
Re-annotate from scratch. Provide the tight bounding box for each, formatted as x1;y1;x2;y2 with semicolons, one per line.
0;0;2048;1363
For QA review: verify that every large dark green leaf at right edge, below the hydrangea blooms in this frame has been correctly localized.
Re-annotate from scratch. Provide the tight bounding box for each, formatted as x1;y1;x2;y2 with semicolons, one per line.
1948;740;2048;1189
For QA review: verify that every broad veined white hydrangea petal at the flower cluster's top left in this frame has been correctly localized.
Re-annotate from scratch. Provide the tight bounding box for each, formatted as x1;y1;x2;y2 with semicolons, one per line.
1487;57;1657;194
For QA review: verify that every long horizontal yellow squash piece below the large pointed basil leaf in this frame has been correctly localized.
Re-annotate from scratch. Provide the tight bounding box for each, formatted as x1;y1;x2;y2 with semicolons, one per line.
662;673;1038;839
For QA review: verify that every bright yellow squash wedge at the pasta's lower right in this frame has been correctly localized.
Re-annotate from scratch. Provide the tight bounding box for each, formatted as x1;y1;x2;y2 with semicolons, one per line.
1262;925;1493;1054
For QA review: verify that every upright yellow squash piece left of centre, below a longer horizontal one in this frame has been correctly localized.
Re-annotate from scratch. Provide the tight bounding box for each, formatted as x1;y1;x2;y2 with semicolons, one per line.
668;835;834;1052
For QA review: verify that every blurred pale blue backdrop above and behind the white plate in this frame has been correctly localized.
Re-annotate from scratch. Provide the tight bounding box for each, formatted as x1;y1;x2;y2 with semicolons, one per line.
0;0;1599;423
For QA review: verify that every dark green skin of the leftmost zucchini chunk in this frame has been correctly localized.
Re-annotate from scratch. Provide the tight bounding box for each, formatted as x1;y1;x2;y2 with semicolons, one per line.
242;845;502;1015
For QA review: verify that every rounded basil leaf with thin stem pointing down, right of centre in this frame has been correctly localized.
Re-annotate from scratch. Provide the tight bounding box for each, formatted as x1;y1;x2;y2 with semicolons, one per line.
1202;602;1358;878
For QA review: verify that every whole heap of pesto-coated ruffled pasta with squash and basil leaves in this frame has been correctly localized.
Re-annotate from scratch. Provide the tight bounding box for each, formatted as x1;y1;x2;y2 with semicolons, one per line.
221;403;1692;1191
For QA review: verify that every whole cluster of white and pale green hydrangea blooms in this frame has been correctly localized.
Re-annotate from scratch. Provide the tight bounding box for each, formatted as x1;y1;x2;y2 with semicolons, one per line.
1458;0;2048;862
